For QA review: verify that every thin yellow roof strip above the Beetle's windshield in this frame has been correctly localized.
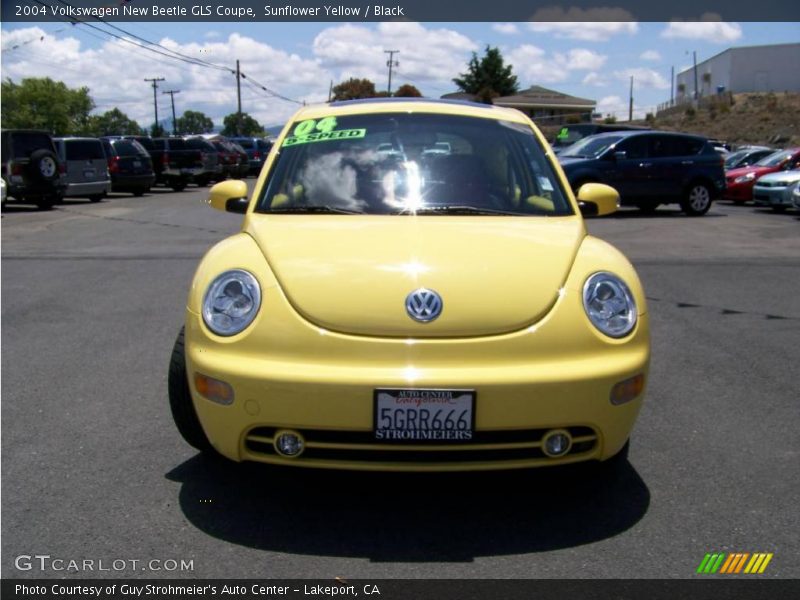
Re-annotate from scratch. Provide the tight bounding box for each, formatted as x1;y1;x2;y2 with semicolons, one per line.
292;98;529;124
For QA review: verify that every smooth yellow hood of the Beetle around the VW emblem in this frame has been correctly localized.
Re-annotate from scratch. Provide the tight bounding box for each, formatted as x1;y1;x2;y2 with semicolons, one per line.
245;214;586;338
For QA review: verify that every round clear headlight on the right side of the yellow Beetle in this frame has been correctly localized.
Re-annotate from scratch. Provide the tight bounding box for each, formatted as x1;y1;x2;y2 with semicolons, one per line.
583;272;636;338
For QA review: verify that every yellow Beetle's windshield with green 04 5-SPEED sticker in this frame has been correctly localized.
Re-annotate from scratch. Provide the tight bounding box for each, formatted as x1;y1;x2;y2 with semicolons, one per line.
256;113;573;215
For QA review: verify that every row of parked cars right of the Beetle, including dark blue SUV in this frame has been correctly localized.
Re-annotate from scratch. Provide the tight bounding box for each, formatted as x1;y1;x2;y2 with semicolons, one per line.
553;124;800;216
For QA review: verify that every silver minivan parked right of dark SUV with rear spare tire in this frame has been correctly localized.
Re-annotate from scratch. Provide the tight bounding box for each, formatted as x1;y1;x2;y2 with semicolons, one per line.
53;137;111;202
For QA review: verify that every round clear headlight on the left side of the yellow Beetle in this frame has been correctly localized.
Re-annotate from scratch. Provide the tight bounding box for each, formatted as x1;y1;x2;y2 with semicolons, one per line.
203;269;261;335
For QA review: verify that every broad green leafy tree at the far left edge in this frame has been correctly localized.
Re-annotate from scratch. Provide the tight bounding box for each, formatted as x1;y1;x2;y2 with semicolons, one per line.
0;77;94;135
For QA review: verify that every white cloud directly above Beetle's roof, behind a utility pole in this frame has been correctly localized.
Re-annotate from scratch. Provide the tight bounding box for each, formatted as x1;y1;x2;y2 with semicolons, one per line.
312;22;477;94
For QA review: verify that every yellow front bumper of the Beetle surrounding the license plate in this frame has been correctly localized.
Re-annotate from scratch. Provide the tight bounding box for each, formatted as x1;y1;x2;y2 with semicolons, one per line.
186;307;649;471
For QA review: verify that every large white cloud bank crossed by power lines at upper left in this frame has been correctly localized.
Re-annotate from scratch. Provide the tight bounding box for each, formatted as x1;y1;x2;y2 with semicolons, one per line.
2;27;330;126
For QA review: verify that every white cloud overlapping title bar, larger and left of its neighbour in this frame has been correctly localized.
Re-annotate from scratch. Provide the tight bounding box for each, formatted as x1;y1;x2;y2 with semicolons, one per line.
528;6;639;42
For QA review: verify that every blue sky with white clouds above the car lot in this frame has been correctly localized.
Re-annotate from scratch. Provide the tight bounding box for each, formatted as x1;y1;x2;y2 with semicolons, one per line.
0;15;800;129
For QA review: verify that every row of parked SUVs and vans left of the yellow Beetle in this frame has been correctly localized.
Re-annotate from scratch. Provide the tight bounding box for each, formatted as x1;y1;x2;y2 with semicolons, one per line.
2;130;272;209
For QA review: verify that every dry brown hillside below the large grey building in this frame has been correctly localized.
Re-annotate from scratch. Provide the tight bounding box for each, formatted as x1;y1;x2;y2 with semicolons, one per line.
542;92;800;148
